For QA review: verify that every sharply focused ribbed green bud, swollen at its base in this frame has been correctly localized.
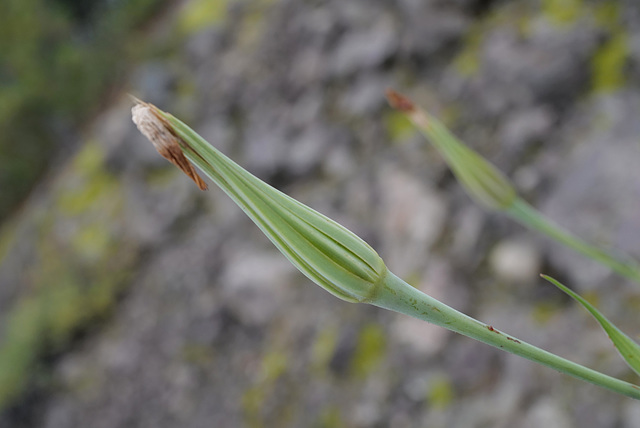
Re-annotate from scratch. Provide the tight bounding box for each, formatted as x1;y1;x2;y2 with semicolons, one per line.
134;104;387;302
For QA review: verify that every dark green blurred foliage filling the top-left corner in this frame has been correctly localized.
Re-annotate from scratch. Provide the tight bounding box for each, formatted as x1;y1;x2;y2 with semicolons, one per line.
0;0;166;222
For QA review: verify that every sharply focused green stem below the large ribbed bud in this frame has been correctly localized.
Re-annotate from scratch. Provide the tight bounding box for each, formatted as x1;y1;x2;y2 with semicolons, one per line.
371;272;640;400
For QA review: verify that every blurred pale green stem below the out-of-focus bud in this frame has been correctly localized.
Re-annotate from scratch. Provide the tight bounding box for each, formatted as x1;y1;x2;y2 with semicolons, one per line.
505;198;640;283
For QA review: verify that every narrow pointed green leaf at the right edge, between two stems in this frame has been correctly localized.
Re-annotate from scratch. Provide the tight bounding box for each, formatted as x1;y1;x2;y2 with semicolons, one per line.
540;275;640;375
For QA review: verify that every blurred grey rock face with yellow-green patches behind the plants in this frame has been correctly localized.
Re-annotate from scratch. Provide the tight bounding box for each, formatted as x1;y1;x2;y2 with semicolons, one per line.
0;0;640;428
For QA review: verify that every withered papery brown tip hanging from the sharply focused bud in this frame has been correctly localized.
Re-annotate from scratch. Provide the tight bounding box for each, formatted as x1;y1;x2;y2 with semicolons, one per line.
131;98;208;190
